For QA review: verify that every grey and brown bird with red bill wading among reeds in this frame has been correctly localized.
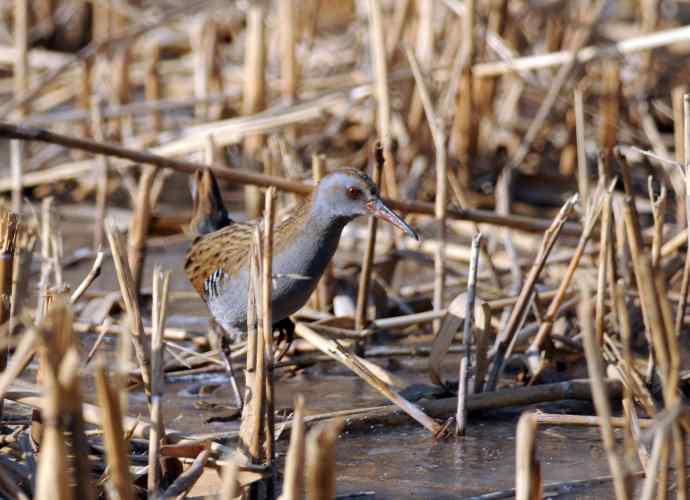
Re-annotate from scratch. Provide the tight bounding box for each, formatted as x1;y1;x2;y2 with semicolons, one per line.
184;168;419;404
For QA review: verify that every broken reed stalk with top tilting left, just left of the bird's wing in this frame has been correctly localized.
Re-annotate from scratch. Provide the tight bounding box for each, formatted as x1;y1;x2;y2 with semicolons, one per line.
105;220;151;400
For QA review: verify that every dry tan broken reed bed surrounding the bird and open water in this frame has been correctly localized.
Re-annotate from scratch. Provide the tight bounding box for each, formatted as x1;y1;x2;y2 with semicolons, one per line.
0;0;690;500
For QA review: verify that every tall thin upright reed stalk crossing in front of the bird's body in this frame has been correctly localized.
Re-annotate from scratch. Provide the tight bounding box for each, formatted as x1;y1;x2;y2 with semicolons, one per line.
258;187;276;498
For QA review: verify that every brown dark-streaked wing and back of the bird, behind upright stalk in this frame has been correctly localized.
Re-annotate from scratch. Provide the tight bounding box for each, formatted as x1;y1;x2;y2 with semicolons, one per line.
184;222;254;298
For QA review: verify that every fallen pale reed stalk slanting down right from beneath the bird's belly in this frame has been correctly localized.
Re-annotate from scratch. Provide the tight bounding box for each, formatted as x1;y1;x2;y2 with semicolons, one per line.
295;323;441;435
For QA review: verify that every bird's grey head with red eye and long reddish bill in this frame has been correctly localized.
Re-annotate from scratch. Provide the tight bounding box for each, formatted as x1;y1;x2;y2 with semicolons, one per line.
315;168;419;240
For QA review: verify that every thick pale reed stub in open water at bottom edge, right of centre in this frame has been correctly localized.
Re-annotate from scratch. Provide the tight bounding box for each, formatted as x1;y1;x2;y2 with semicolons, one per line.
515;412;543;500
